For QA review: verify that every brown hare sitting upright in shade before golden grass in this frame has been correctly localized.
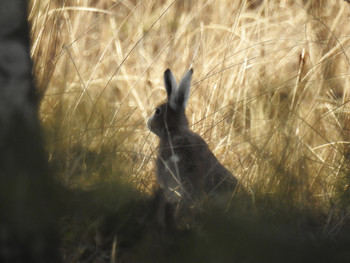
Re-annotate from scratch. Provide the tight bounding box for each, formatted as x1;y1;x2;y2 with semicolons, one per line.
147;69;237;202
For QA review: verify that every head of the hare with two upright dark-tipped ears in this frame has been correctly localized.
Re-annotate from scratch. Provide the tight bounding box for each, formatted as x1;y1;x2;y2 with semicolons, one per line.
147;69;193;138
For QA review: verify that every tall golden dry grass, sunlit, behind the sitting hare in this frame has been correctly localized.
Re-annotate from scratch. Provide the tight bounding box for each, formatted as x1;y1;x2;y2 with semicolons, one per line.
30;0;350;229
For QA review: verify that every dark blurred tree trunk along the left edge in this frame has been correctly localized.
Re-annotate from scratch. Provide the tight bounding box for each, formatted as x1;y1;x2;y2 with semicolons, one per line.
0;0;59;262
